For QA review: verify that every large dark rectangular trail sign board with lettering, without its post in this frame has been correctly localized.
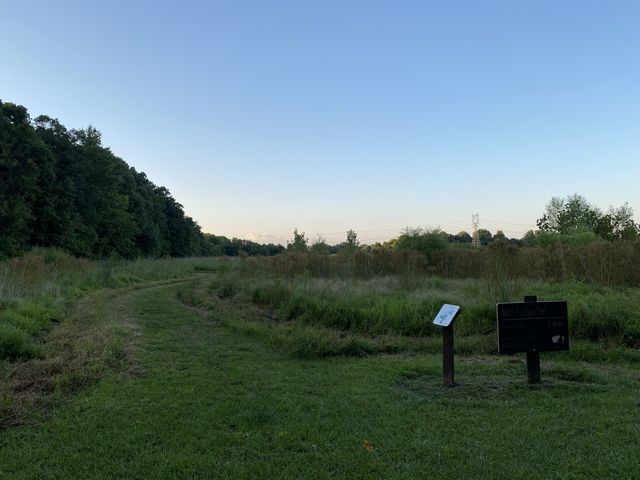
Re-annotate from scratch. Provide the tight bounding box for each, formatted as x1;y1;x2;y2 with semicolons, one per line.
496;301;569;354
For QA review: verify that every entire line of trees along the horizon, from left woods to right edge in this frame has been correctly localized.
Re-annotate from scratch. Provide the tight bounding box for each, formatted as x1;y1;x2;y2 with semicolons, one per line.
0;101;640;258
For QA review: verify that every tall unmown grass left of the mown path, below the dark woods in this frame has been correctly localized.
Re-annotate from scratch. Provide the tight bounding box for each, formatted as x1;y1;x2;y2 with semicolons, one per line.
0;248;225;359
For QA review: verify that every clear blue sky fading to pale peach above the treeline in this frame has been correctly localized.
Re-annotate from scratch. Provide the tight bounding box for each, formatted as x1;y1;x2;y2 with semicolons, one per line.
0;0;640;243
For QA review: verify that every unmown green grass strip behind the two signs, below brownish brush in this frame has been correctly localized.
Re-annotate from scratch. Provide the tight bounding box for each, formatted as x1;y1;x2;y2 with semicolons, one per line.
202;264;640;348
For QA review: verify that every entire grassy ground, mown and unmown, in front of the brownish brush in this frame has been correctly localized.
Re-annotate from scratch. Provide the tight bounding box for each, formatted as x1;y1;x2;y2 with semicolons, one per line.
0;250;640;479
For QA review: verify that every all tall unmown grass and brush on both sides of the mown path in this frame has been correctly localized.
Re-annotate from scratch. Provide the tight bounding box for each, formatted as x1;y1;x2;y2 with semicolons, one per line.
5;242;640;358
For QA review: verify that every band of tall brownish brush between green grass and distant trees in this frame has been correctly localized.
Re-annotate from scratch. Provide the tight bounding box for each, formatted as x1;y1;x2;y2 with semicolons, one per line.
247;240;640;287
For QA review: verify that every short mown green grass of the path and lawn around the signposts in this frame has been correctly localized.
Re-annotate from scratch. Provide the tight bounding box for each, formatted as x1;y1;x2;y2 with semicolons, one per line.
0;286;640;479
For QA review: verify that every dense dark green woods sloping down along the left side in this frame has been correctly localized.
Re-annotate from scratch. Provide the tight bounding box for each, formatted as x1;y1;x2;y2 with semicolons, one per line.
0;101;205;258
